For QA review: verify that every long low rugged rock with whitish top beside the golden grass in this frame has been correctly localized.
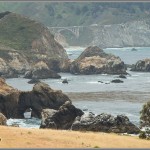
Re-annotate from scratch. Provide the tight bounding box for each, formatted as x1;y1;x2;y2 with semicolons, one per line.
71;113;140;134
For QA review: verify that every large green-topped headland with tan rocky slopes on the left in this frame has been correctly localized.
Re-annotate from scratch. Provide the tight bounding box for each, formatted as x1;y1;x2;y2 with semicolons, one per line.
0;12;68;77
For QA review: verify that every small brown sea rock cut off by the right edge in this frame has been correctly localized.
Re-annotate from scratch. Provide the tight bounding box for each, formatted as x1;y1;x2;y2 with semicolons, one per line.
131;59;150;72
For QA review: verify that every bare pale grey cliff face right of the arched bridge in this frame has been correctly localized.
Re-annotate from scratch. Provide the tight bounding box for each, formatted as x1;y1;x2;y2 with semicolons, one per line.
92;20;150;47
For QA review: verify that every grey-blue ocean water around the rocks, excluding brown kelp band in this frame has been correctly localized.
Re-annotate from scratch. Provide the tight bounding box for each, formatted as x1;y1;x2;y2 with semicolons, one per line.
6;47;150;128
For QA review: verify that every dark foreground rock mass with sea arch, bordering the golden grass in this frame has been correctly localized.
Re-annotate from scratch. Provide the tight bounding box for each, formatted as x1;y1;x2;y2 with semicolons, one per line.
0;79;140;134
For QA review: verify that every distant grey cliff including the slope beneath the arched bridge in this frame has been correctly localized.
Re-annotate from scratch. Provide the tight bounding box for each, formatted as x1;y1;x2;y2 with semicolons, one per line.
54;19;150;48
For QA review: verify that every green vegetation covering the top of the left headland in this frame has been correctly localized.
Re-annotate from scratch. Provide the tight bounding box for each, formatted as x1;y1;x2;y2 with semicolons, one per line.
0;13;46;50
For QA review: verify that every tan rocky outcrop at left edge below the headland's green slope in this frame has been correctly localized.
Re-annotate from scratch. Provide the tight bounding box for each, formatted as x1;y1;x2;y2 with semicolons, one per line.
0;47;30;78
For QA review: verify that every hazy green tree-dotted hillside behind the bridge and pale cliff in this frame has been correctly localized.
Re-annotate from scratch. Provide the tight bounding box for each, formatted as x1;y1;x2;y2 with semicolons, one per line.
0;1;150;26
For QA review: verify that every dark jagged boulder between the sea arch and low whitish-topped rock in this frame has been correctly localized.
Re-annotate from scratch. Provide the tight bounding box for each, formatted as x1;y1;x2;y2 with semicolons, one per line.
40;101;83;129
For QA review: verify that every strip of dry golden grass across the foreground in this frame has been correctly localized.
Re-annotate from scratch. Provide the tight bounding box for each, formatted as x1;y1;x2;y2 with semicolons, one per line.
0;126;150;148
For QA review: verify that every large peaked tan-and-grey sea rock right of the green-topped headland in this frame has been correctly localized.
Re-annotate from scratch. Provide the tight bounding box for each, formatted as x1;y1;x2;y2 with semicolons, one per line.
70;46;126;74
